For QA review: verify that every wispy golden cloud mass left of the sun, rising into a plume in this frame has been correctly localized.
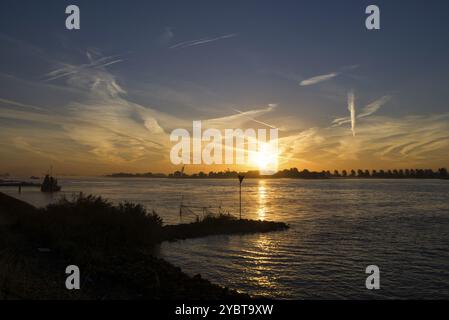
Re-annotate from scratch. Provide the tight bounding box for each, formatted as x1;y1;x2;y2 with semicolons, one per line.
0;51;169;166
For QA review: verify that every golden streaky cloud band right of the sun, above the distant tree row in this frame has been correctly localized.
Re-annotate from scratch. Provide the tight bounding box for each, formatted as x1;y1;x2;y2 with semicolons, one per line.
279;113;449;169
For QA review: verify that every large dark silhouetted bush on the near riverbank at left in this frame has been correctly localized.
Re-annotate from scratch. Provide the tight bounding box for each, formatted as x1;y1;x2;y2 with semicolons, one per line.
22;195;162;255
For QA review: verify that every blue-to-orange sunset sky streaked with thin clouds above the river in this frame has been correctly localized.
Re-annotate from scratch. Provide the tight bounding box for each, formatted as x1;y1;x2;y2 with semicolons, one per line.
0;0;449;175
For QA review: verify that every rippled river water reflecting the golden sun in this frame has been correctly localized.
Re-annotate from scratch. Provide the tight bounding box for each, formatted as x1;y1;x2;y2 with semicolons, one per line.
0;178;449;299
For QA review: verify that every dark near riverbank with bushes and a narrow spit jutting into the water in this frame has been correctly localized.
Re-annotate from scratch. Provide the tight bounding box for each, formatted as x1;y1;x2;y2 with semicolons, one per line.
0;193;288;299
